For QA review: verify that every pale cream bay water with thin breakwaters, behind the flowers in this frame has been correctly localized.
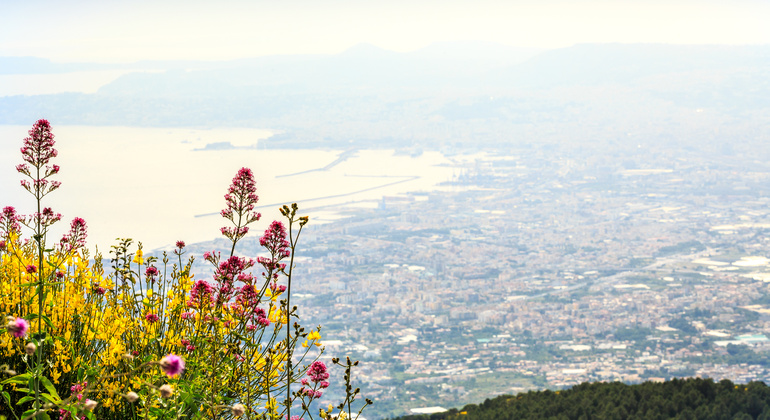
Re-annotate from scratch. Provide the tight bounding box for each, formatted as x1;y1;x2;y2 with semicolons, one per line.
0;122;456;249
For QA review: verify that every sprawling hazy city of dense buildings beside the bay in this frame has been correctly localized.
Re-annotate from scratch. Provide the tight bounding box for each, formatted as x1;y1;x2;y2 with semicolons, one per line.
186;142;770;418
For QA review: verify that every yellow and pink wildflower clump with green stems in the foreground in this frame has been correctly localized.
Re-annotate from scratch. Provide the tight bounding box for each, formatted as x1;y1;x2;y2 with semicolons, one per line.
0;120;371;420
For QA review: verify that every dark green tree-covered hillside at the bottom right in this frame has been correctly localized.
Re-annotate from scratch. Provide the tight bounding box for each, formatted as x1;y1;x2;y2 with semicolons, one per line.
398;378;770;420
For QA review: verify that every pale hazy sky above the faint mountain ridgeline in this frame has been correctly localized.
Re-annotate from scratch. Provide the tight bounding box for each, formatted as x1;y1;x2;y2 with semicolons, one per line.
0;0;770;62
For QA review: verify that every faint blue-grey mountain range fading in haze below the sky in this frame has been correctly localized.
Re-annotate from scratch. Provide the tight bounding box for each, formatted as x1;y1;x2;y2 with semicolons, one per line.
0;42;770;149
